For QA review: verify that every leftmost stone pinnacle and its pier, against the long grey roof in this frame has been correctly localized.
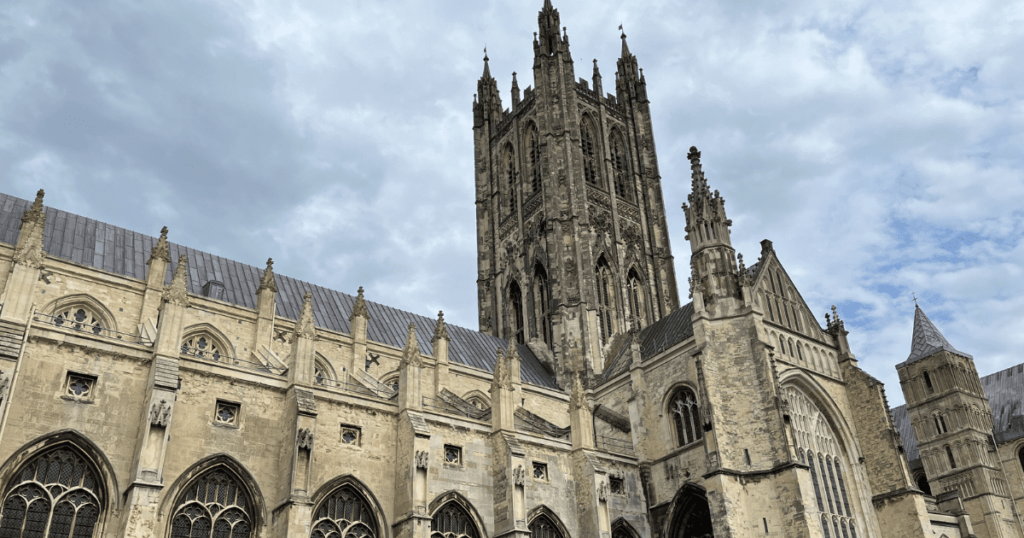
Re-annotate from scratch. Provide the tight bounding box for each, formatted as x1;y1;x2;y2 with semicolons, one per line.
0;189;46;327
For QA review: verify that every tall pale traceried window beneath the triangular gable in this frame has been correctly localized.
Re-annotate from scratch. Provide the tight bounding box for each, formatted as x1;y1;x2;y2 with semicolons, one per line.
785;386;857;538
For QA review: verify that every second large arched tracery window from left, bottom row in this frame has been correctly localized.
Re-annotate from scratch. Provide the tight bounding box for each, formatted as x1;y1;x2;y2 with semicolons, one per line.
171;467;255;538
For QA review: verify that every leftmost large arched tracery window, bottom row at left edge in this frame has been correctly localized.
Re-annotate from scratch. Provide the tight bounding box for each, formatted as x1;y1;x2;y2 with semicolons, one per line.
0;446;104;538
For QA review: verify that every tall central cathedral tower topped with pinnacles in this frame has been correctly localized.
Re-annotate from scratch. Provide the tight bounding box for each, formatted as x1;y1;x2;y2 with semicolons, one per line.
473;0;679;387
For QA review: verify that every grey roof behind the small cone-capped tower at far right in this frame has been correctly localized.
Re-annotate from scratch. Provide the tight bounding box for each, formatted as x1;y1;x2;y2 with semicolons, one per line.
892;364;1024;462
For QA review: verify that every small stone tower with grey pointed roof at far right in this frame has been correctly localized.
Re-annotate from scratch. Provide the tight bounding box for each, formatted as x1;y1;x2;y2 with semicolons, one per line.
896;306;1020;538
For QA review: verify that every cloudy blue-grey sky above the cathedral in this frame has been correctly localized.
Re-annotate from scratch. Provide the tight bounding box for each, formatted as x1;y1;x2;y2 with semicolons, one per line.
0;0;1024;405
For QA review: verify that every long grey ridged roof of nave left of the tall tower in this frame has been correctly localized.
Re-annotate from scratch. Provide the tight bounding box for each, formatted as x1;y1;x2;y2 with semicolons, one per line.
0;193;557;388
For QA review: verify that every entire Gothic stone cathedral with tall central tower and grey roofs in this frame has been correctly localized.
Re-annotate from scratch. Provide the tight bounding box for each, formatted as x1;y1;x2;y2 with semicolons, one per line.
0;0;1024;538
